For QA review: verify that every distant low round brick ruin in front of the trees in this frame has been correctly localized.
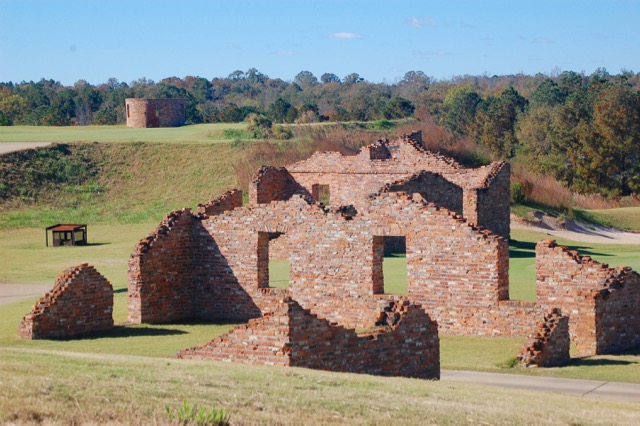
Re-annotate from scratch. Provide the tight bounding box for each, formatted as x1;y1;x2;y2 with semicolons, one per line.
124;98;186;128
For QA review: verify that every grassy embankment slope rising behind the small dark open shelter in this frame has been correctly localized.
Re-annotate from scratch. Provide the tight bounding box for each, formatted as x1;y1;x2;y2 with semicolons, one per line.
0;143;246;229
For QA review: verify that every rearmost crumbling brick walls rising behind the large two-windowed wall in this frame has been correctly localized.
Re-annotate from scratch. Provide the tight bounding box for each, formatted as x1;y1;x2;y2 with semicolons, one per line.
255;132;510;238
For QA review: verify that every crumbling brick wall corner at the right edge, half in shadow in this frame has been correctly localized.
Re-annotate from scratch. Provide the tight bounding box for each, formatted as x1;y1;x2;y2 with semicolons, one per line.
536;240;640;356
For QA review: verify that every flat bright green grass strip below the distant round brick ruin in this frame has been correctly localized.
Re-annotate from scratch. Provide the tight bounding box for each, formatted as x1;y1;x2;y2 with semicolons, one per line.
0;123;246;143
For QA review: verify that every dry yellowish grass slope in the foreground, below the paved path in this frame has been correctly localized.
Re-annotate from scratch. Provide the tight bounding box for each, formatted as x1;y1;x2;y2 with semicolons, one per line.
0;349;640;425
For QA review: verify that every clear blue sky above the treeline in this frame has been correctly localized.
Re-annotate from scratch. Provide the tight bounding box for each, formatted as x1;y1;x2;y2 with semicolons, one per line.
0;0;640;85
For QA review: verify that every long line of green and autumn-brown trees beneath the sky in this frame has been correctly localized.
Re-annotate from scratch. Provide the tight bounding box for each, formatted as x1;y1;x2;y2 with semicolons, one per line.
0;69;640;195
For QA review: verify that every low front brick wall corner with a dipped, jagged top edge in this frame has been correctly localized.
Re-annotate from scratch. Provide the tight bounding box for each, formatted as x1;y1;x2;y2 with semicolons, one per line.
177;298;440;379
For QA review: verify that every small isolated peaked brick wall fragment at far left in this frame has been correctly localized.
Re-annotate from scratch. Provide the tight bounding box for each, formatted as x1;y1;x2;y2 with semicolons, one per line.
19;263;113;339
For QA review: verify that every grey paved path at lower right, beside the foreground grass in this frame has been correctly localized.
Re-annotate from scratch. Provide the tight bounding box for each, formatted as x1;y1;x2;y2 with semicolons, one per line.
440;370;640;403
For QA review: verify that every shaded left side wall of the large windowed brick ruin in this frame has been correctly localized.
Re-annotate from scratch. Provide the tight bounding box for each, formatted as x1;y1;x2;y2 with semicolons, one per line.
129;209;260;323
